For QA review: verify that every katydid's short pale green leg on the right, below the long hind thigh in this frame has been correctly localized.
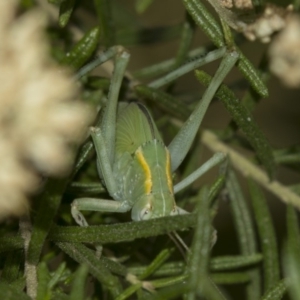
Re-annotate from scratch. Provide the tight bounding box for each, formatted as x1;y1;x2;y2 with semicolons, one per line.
174;152;226;194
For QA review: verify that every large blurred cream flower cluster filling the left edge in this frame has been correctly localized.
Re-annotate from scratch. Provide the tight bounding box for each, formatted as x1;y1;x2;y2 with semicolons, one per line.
0;0;92;219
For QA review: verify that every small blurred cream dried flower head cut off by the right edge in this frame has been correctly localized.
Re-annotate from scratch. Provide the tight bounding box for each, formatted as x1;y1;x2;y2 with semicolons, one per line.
269;15;300;88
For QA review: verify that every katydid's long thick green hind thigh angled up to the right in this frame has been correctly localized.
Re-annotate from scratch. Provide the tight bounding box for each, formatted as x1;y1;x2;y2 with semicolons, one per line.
168;51;239;172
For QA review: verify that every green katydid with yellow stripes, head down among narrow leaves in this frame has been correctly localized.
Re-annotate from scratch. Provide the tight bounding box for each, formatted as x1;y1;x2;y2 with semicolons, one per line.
72;46;238;226
